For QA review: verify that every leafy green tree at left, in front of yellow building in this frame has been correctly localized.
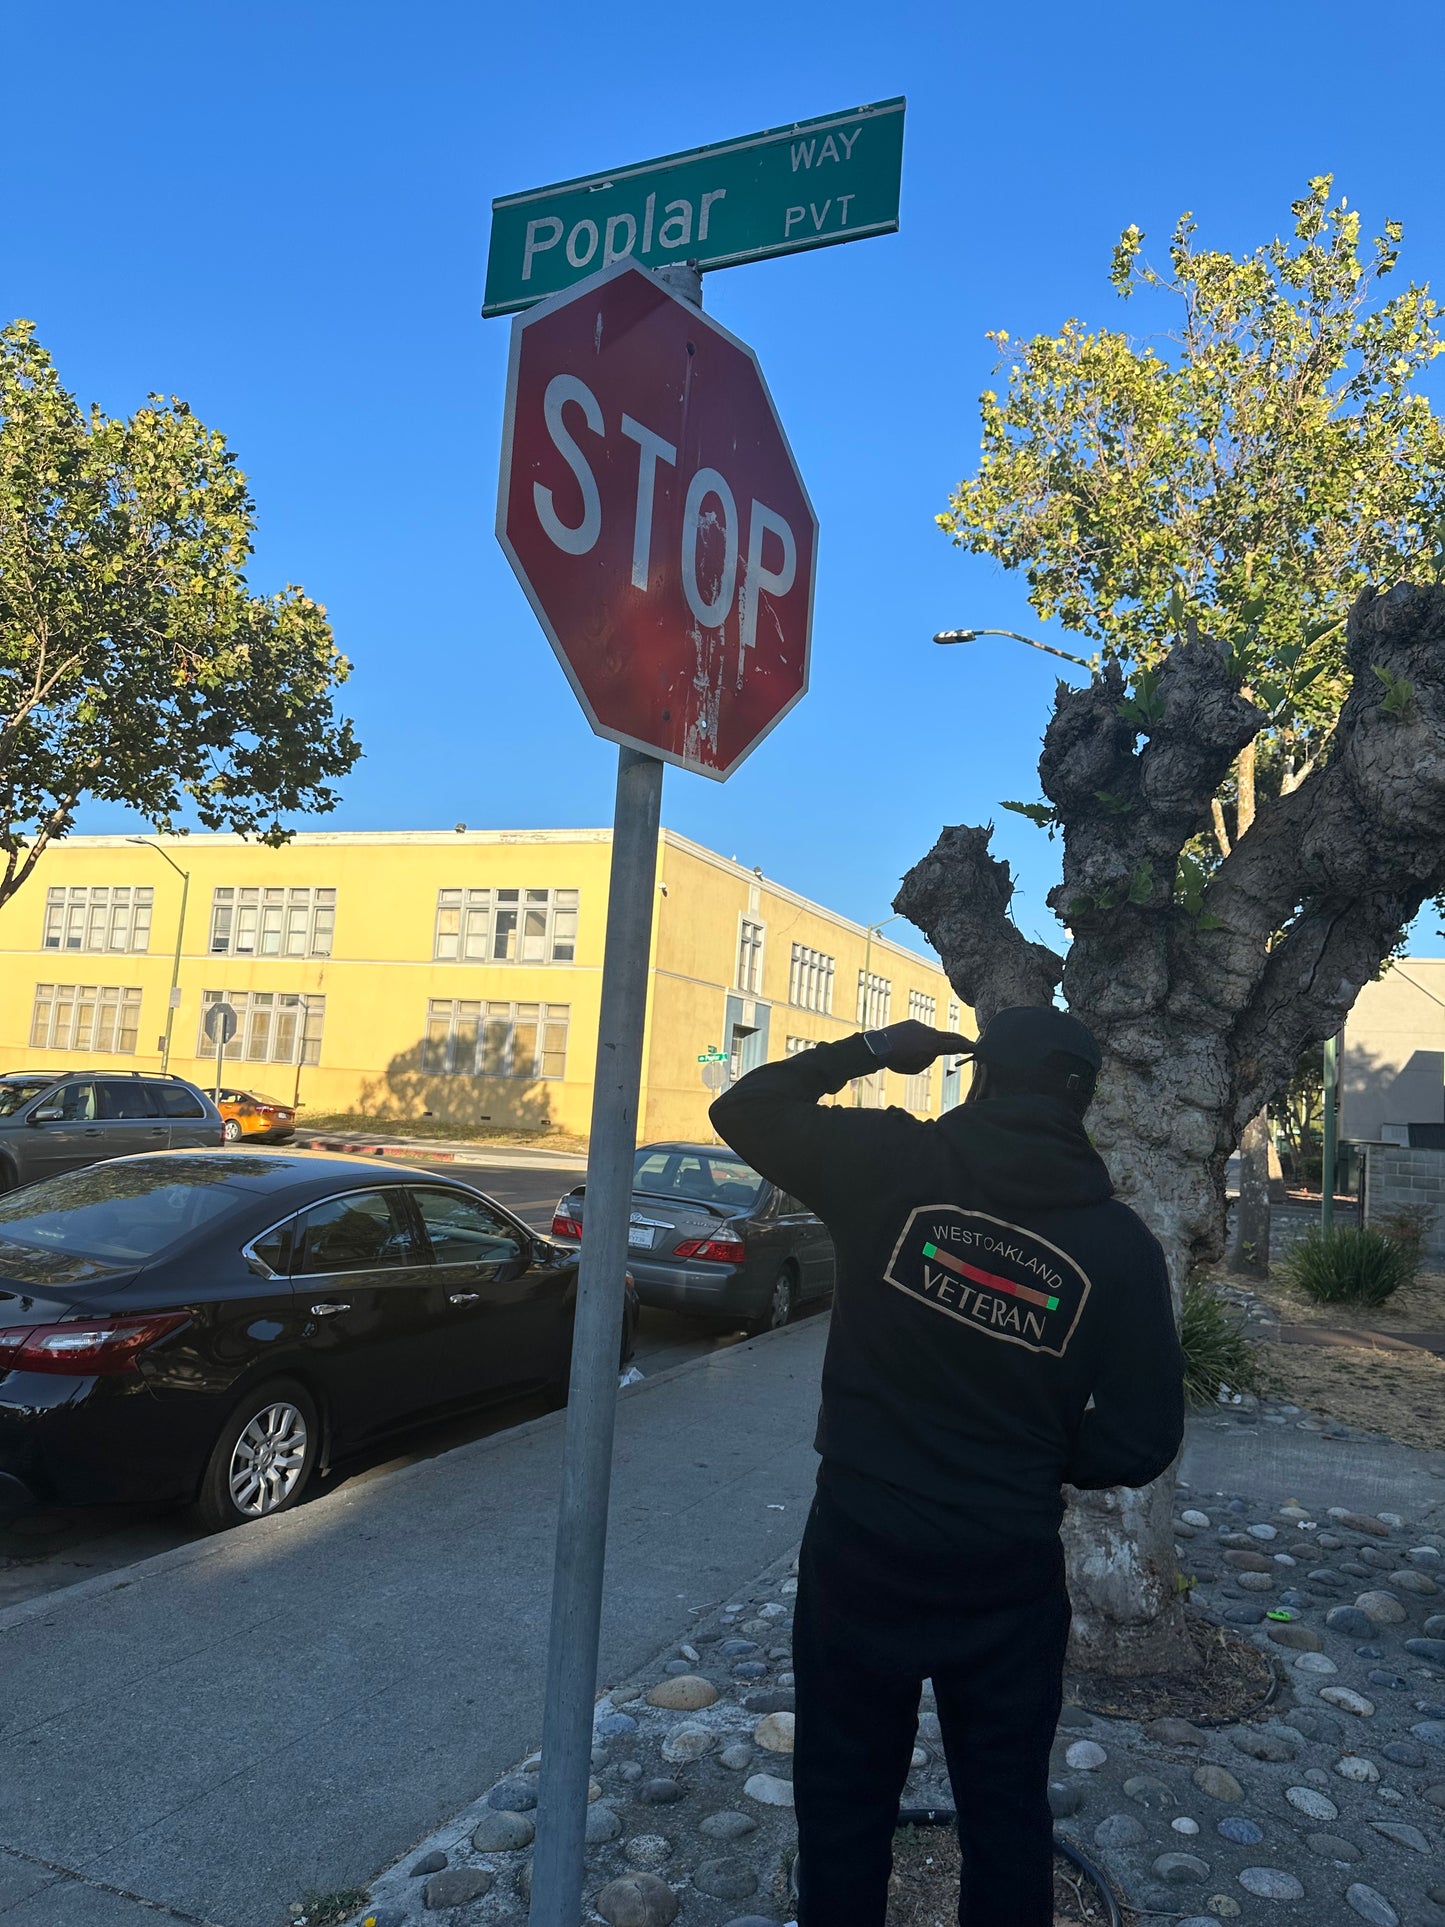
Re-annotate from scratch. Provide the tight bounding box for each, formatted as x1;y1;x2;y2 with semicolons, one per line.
0;322;360;904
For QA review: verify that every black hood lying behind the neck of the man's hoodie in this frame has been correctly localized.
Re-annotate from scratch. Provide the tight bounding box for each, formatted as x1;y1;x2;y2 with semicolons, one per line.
938;1095;1114;1210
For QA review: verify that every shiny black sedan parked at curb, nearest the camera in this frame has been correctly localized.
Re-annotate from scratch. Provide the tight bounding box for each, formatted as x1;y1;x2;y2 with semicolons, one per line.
0;1150;638;1530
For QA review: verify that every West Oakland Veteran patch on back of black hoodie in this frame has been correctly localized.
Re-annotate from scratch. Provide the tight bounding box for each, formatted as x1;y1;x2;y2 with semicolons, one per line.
882;1204;1089;1359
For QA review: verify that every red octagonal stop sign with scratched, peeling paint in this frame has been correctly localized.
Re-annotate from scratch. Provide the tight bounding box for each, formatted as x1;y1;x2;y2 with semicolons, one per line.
497;262;817;779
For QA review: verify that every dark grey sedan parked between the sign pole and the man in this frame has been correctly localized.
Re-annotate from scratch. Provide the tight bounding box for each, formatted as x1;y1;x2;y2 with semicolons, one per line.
551;1145;834;1333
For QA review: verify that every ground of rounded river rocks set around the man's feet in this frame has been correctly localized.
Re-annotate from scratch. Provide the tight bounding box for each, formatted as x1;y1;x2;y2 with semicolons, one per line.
342;1407;1445;1927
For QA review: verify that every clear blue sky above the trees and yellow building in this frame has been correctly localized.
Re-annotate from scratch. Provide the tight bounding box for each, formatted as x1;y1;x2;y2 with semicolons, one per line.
0;0;1445;955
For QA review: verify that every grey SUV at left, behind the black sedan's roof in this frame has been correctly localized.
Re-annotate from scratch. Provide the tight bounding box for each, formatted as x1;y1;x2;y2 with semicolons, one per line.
0;1071;222;1191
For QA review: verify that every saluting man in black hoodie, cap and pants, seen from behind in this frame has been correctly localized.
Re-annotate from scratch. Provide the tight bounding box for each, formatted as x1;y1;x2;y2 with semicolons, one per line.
711;1008;1183;1927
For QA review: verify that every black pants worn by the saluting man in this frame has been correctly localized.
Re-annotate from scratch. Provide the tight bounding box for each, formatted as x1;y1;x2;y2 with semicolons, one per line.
794;1484;1069;1927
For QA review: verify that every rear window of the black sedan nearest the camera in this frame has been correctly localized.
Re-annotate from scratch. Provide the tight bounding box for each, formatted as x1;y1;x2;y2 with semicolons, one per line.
0;1158;245;1283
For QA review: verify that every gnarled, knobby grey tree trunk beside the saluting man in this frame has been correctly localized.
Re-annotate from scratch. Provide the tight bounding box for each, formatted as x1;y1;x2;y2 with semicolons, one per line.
894;584;1445;1673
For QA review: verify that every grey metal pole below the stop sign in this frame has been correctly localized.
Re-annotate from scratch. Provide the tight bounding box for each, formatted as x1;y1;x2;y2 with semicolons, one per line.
528;750;663;1927
